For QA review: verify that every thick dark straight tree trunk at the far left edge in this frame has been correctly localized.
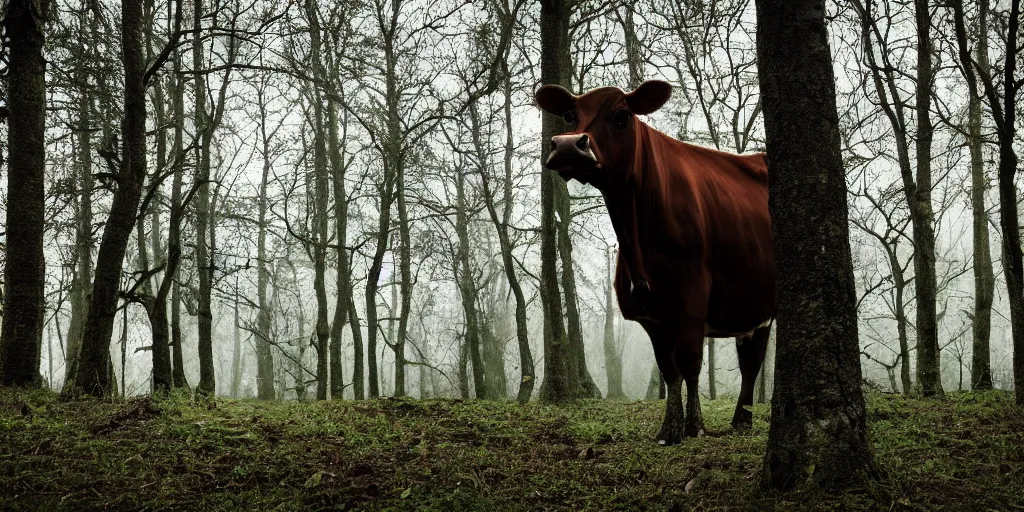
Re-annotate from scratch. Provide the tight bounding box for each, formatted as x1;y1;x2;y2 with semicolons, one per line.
0;0;48;387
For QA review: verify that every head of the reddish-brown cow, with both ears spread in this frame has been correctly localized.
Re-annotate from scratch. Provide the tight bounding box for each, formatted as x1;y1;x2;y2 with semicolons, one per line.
534;80;672;186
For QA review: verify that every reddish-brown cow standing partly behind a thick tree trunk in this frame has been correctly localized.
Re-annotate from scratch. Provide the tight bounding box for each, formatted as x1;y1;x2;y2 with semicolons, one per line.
535;81;775;444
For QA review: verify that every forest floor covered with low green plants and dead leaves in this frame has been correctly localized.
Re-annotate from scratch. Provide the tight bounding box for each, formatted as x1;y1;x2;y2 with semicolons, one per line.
0;390;1024;511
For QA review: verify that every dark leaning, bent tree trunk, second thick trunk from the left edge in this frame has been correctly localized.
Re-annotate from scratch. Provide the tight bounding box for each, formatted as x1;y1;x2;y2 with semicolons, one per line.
75;1;145;396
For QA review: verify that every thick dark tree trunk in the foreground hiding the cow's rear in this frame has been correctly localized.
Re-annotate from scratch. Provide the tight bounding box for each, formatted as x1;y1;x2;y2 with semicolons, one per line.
757;0;877;489
